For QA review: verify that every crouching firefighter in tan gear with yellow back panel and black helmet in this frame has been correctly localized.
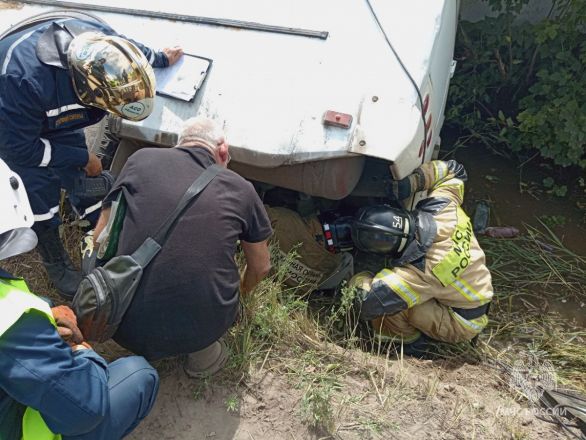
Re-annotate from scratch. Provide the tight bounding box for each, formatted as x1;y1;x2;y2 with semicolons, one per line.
350;160;493;357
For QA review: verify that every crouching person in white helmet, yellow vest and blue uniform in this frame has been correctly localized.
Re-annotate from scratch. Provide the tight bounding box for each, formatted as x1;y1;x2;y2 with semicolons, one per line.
0;160;159;440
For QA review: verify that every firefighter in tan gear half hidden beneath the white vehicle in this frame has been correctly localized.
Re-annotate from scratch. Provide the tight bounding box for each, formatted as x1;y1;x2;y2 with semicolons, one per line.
266;207;354;290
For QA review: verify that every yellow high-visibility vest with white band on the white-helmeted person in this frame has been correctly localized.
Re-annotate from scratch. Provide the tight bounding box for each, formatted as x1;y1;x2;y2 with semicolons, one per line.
0;278;61;440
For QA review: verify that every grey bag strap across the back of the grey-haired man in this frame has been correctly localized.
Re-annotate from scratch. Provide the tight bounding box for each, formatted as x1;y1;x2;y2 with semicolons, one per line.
132;164;222;268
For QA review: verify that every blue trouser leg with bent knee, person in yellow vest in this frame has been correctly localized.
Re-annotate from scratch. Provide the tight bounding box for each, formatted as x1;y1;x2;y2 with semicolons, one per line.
63;356;159;440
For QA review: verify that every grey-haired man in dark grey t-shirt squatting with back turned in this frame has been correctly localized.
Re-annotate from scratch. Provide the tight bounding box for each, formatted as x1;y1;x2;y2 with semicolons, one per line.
94;118;272;375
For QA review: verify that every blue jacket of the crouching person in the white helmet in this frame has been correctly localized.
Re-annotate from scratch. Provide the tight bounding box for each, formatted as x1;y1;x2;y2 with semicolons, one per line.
0;269;110;440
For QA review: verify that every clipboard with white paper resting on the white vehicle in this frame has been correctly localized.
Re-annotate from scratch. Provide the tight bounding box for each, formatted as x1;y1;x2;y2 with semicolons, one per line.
153;53;212;102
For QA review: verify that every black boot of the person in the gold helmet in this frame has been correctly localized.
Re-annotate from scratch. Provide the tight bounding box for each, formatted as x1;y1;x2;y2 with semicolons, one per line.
35;228;81;300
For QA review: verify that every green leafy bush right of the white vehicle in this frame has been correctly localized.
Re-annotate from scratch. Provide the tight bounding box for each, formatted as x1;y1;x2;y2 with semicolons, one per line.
446;0;586;169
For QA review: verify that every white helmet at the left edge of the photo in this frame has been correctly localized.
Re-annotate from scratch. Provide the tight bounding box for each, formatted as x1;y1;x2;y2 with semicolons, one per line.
0;159;37;260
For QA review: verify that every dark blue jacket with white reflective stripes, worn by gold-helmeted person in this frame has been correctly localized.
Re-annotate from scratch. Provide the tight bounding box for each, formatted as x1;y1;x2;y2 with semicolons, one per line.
0;19;168;167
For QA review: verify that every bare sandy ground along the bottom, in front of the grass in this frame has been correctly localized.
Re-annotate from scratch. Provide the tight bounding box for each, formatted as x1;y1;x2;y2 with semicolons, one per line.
124;355;563;440
